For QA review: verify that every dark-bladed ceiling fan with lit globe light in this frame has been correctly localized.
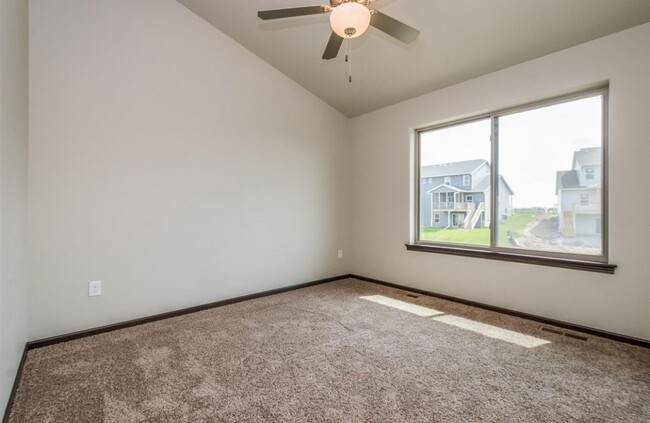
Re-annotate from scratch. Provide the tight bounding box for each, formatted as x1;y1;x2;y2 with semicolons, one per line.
257;0;420;60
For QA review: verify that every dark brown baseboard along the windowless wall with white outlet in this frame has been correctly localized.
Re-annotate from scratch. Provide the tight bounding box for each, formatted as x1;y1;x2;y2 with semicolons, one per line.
27;275;350;350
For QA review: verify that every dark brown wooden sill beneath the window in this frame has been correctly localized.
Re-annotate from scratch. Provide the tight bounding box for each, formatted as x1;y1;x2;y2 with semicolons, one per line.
406;244;616;275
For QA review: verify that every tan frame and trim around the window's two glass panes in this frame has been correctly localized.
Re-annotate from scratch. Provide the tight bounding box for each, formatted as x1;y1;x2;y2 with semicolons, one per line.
407;84;615;273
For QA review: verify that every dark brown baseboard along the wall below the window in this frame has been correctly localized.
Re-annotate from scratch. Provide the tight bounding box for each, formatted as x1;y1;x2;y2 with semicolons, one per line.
350;275;650;348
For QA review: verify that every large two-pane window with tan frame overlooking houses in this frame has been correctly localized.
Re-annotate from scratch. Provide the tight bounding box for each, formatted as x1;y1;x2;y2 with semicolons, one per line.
412;88;615;269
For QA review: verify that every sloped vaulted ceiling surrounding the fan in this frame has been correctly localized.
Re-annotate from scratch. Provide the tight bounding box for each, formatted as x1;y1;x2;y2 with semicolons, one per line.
178;0;650;117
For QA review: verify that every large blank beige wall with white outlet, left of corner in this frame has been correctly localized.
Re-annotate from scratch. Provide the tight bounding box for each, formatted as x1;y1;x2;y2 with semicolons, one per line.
29;0;351;339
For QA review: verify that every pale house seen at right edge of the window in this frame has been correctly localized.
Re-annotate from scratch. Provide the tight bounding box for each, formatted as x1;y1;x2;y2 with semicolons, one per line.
555;147;603;236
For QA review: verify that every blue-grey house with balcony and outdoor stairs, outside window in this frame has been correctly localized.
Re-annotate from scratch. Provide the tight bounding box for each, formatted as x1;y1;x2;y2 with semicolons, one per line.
420;159;514;229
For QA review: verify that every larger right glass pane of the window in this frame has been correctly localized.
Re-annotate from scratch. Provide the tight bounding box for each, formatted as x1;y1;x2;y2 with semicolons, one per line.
497;95;603;255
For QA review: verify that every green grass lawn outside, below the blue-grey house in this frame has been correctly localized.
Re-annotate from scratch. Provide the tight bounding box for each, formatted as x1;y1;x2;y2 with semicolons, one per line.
420;211;535;245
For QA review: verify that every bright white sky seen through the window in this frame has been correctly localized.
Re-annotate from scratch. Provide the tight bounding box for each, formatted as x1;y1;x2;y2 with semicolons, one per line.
421;95;602;208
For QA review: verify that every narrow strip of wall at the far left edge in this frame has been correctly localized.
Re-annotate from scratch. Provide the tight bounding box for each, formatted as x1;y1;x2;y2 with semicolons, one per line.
0;0;28;415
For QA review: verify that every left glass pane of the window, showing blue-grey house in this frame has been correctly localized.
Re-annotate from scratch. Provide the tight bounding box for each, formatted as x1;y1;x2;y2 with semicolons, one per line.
419;119;491;246
